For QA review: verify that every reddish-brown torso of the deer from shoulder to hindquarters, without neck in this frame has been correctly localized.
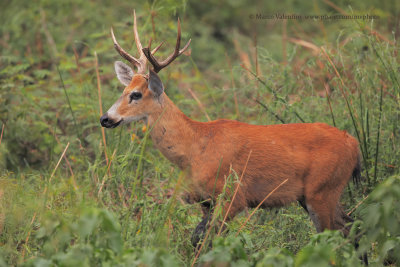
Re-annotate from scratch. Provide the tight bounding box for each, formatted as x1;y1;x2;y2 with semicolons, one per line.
186;120;360;235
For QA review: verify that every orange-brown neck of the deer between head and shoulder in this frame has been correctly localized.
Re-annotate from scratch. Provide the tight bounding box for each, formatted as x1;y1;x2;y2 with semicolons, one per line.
147;93;196;169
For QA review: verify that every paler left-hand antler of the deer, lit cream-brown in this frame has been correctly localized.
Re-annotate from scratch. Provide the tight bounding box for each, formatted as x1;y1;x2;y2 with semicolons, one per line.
111;10;163;74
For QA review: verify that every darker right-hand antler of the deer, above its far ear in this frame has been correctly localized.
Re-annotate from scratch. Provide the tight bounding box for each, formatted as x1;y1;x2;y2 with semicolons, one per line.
142;18;192;72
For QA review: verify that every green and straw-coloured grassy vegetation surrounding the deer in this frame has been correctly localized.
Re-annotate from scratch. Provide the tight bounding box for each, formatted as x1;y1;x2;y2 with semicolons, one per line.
0;0;400;266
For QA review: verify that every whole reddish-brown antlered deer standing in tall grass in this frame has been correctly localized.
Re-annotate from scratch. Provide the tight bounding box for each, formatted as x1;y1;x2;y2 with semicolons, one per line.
100;11;360;251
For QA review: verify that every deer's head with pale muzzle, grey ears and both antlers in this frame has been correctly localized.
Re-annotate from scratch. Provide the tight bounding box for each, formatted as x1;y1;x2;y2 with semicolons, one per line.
100;11;191;128
